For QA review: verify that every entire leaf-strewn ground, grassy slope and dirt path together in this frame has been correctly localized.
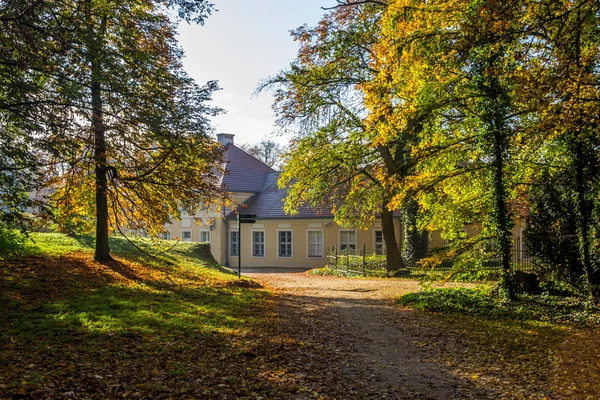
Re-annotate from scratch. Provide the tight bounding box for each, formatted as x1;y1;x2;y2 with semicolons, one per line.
0;235;600;399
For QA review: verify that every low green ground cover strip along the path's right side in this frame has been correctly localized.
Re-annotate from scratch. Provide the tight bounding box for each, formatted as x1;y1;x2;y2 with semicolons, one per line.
398;286;600;324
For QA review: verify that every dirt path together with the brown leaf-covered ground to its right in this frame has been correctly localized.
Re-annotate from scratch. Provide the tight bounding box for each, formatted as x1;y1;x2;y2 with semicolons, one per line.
247;274;600;399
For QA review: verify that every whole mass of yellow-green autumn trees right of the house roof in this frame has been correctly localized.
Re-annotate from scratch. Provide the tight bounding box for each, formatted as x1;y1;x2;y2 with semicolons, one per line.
268;0;600;298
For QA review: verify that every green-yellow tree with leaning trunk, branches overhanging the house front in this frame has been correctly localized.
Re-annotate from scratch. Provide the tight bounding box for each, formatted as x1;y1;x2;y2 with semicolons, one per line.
265;2;404;271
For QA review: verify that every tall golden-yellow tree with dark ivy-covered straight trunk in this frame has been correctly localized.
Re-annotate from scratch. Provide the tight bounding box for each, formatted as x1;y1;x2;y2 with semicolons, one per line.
368;0;523;297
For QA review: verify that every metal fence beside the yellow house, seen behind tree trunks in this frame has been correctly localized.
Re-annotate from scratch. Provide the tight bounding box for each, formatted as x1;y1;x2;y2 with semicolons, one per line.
326;237;533;275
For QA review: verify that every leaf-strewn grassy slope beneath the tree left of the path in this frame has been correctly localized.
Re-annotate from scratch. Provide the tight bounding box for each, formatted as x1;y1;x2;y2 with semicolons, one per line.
0;234;290;398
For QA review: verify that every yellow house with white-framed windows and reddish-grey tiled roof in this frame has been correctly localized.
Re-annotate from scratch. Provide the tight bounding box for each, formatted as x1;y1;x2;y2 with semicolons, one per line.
163;133;400;268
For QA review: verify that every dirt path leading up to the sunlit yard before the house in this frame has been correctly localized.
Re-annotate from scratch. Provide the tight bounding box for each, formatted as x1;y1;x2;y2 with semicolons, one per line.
247;273;489;399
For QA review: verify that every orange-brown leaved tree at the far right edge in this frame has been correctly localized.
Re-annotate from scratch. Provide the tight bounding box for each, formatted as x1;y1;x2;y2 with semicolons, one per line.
530;1;600;301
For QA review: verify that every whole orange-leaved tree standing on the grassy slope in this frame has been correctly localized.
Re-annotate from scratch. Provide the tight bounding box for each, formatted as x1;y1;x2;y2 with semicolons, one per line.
0;0;225;261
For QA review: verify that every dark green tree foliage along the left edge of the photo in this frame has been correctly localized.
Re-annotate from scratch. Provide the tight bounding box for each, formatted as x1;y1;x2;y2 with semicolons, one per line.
0;0;74;226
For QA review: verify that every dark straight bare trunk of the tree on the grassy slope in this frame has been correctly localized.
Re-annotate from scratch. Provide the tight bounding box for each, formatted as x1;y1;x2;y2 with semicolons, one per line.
90;19;113;261
